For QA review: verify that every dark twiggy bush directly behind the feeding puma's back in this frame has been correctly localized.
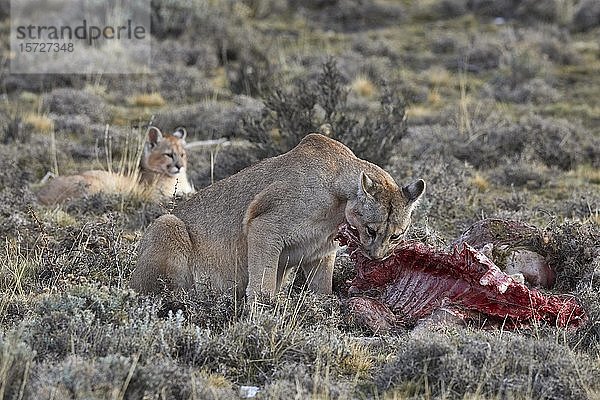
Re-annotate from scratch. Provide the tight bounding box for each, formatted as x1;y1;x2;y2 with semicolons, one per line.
241;60;406;165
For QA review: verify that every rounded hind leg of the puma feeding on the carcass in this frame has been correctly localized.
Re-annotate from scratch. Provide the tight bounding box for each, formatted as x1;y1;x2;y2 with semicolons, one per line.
129;214;194;293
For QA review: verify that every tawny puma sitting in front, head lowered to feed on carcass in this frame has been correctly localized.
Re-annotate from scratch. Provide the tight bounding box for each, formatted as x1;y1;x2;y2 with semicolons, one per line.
130;133;425;299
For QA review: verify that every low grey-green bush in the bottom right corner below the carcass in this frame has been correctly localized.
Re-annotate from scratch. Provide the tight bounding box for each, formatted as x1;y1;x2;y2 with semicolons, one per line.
376;330;600;400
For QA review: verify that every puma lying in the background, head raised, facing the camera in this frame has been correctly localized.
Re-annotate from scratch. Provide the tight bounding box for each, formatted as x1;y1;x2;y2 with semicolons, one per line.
36;126;194;205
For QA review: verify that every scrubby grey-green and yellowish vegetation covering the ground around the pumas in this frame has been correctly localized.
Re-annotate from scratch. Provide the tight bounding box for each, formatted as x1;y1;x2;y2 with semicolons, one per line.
0;0;600;399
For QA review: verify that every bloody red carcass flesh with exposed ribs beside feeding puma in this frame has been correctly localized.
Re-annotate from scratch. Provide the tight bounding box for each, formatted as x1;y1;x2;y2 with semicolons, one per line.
338;227;586;327
